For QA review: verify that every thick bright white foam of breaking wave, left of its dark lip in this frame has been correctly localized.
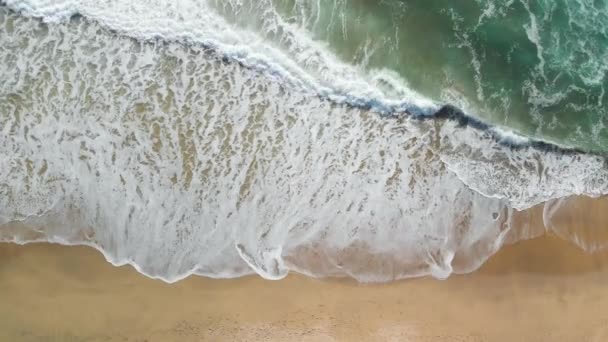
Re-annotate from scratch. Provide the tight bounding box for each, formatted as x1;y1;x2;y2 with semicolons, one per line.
5;0;437;114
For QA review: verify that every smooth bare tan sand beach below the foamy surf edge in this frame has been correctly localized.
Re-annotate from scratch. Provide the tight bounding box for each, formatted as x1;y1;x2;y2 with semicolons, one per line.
0;196;608;342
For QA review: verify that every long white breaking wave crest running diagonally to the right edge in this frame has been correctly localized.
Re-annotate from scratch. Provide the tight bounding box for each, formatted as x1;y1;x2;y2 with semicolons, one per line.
4;0;602;155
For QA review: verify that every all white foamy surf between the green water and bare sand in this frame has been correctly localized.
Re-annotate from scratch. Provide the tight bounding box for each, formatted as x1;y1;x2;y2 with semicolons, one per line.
0;0;608;281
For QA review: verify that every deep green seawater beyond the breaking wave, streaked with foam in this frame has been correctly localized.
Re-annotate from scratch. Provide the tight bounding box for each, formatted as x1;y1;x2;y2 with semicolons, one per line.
214;0;608;153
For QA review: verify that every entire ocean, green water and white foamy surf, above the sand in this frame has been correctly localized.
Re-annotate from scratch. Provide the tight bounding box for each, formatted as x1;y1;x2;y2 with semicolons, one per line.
0;0;608;282
